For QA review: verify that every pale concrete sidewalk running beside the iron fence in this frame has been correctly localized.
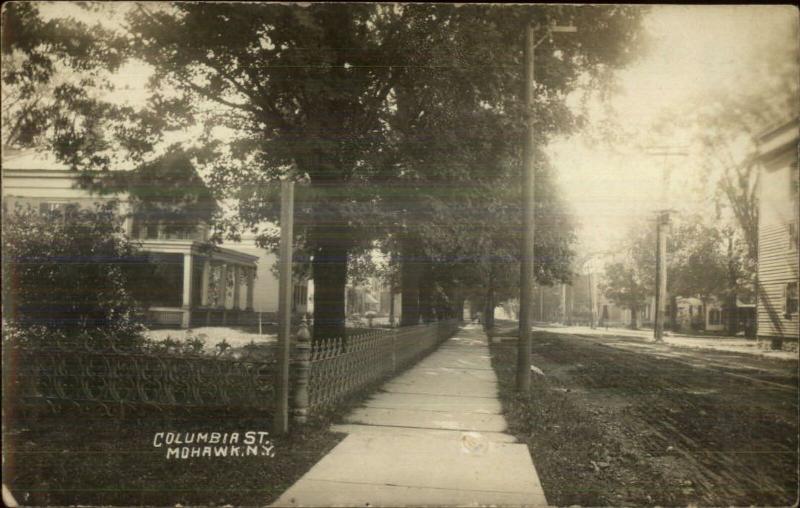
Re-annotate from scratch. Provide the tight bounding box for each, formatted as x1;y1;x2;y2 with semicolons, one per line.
273;326;547;507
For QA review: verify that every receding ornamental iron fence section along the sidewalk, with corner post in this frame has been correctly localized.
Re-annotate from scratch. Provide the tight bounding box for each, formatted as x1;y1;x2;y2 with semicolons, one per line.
304;319;458;412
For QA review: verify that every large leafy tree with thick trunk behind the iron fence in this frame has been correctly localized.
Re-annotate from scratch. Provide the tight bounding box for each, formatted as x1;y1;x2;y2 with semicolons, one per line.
4;3;642;336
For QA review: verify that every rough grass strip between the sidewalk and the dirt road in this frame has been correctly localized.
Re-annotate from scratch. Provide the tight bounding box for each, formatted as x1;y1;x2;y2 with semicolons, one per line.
490;336;689;506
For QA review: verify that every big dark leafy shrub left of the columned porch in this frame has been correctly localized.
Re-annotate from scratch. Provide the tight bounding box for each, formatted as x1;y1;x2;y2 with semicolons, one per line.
2;200;152;346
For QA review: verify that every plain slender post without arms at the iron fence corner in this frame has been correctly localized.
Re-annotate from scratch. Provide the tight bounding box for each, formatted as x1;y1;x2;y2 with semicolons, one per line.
273;180;294;435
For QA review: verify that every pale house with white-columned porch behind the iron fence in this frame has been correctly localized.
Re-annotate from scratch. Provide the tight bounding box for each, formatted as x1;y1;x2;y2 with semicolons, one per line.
2;152;309;328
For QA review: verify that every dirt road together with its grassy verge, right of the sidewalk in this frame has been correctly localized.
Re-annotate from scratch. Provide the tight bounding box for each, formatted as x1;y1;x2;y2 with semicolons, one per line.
493;332;798;506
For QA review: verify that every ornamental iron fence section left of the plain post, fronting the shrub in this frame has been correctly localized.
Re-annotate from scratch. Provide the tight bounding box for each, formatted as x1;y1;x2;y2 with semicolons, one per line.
3;341;275;415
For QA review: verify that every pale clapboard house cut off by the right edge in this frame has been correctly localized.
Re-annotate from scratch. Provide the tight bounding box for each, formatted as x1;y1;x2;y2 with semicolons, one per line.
756;118;800;347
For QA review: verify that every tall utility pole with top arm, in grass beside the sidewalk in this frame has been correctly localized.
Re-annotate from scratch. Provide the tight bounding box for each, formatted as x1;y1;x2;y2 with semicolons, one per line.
517;24;577;393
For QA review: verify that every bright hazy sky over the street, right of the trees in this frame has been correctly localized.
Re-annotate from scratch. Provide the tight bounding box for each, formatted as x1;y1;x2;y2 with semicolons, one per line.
548;5;798;252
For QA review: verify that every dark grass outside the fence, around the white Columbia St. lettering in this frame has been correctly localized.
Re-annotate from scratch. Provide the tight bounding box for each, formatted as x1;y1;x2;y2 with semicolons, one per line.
3;414;343;506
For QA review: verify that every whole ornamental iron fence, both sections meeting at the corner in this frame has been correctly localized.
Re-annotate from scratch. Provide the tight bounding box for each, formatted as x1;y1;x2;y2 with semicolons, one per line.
3;319;458;423
